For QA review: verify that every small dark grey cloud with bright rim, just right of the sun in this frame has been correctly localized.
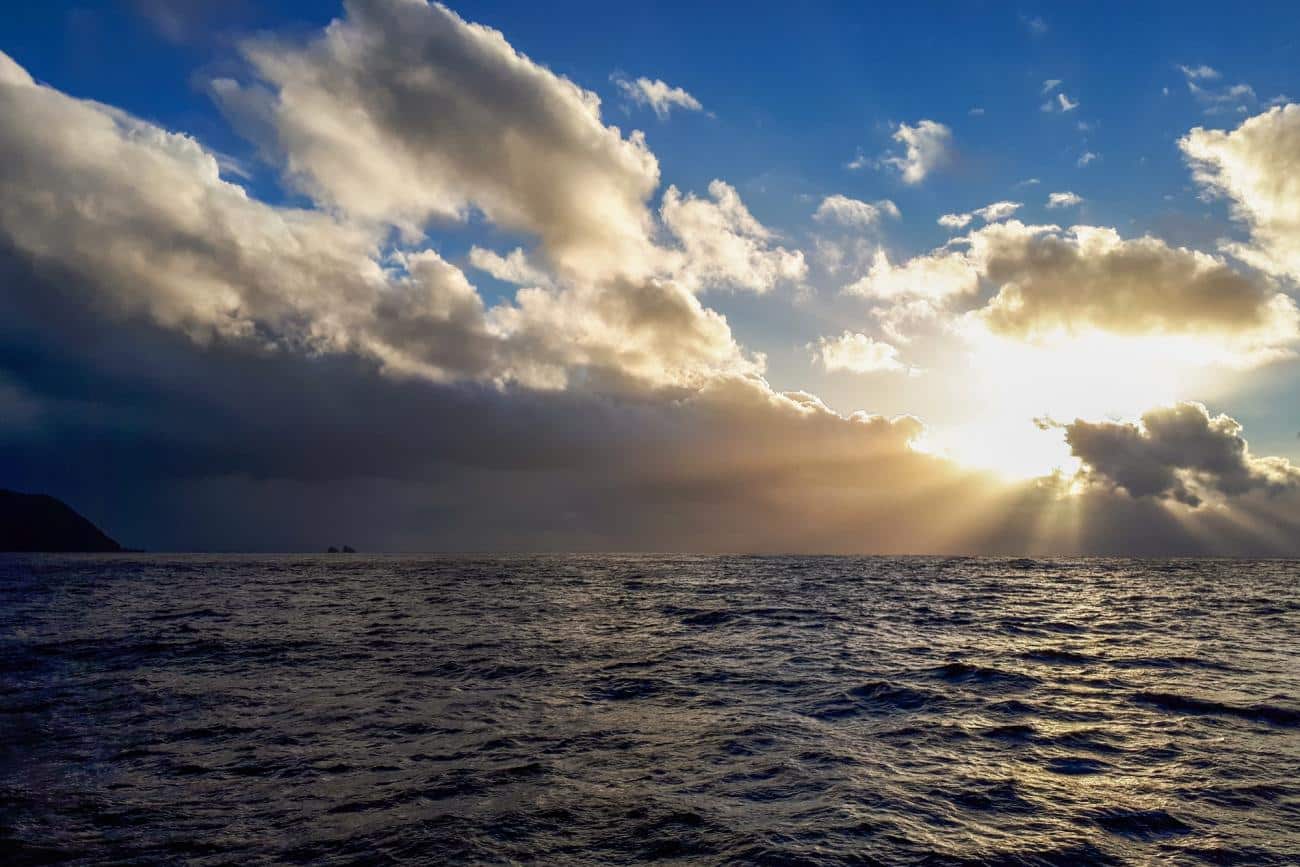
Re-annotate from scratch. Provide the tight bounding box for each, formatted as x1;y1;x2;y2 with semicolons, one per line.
1065;403;1300;508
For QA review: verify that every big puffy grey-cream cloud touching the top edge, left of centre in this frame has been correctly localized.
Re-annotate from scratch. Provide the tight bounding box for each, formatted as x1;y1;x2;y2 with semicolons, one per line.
218;0;659;278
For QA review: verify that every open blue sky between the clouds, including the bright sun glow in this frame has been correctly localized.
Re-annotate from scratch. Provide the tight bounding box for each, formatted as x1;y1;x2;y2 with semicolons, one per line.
0;0;1300;548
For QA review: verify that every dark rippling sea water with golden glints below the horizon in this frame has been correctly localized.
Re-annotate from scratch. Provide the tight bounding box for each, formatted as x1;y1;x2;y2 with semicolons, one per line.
0;556;1300;864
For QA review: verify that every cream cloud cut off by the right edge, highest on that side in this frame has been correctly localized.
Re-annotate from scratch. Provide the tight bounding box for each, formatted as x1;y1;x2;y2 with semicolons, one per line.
1178;105;1300;281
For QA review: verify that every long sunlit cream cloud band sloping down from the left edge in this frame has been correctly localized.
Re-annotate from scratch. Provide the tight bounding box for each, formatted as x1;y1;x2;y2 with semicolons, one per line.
0;44;754;387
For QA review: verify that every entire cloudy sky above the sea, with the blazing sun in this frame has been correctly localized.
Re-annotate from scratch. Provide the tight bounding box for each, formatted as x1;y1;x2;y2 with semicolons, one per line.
0;0;1300;555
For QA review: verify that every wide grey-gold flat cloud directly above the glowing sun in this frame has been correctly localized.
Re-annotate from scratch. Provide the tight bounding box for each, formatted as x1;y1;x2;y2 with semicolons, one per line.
844;220;1300;365
